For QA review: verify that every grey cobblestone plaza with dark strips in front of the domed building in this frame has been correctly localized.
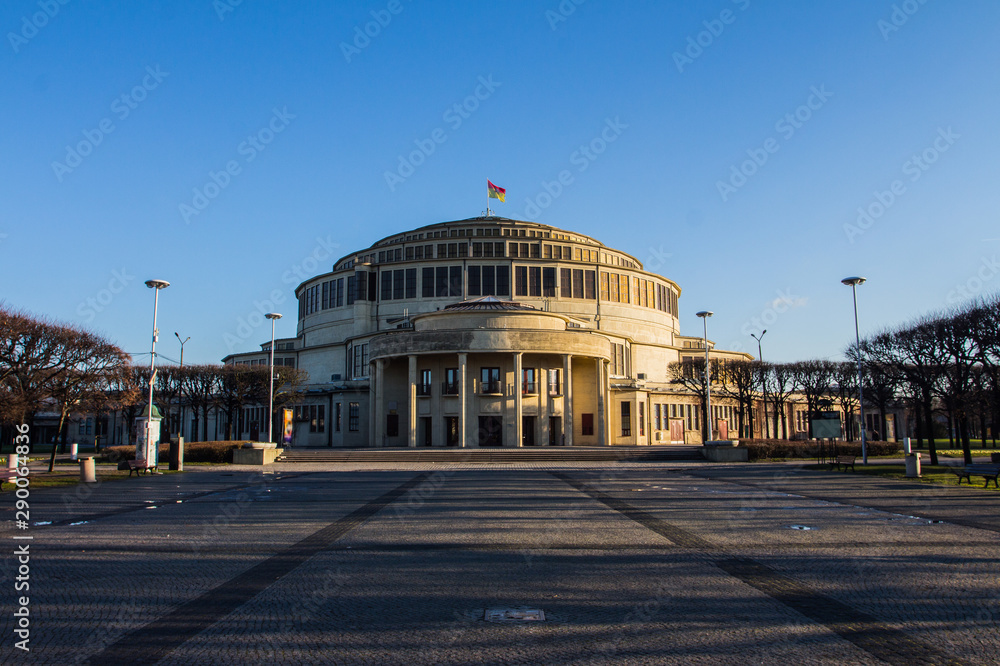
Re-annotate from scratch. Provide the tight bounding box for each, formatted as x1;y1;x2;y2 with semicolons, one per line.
0;463;1000;666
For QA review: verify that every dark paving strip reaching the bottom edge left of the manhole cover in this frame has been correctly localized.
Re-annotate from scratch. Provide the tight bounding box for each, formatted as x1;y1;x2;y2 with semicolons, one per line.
87;473;429;666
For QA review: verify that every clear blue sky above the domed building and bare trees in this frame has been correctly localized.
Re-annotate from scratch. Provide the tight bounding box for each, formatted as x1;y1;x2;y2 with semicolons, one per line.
0;0;1000;362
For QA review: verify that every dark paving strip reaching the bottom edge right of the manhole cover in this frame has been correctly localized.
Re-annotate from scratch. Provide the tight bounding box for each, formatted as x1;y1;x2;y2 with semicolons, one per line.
549;472;964;666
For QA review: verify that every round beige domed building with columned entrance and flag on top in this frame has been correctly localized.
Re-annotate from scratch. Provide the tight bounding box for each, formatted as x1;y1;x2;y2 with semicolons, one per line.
223;216;749;447
